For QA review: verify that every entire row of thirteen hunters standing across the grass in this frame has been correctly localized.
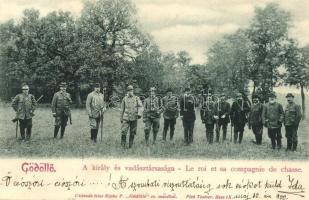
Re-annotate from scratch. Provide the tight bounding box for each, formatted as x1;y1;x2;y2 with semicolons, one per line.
12;83;301;150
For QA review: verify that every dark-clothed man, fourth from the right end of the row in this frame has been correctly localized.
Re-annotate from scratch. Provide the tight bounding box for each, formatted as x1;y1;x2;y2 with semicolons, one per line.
230;93;250;144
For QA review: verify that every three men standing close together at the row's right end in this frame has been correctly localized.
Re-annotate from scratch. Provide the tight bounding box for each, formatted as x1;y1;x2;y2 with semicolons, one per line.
249;92;302;151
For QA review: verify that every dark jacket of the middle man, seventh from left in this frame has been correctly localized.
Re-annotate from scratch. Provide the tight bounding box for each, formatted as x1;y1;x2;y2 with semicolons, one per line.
180;94;196;122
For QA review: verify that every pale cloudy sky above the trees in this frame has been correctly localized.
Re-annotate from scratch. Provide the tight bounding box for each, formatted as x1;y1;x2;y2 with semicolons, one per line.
0;0;309;63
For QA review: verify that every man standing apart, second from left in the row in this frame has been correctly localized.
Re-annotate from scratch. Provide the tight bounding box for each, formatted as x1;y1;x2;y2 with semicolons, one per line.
51;82;72;139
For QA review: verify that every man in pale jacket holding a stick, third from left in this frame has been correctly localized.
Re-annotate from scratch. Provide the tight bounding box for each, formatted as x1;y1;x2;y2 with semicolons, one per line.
86;83;106;143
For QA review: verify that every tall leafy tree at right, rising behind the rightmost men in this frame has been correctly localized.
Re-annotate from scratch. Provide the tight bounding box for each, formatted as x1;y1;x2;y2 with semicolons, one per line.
247;3;291;97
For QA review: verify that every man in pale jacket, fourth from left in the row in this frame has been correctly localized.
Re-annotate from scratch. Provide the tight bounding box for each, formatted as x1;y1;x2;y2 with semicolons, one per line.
120;85;143;148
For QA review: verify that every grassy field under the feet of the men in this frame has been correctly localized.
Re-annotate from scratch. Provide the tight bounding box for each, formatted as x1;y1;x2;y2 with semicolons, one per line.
0;94;309;160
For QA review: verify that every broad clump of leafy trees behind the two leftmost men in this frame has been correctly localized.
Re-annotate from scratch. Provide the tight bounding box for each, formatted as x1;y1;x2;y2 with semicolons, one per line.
1;9;82;105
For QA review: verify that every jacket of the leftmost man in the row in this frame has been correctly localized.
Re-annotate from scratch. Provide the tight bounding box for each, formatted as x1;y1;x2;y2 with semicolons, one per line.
12;93;36;119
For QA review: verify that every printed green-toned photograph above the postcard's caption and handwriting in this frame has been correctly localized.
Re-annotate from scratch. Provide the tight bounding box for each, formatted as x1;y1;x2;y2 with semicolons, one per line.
0;0;309;161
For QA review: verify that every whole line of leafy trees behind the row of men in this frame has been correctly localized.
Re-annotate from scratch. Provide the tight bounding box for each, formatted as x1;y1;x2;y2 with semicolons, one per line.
0;0;309;117
